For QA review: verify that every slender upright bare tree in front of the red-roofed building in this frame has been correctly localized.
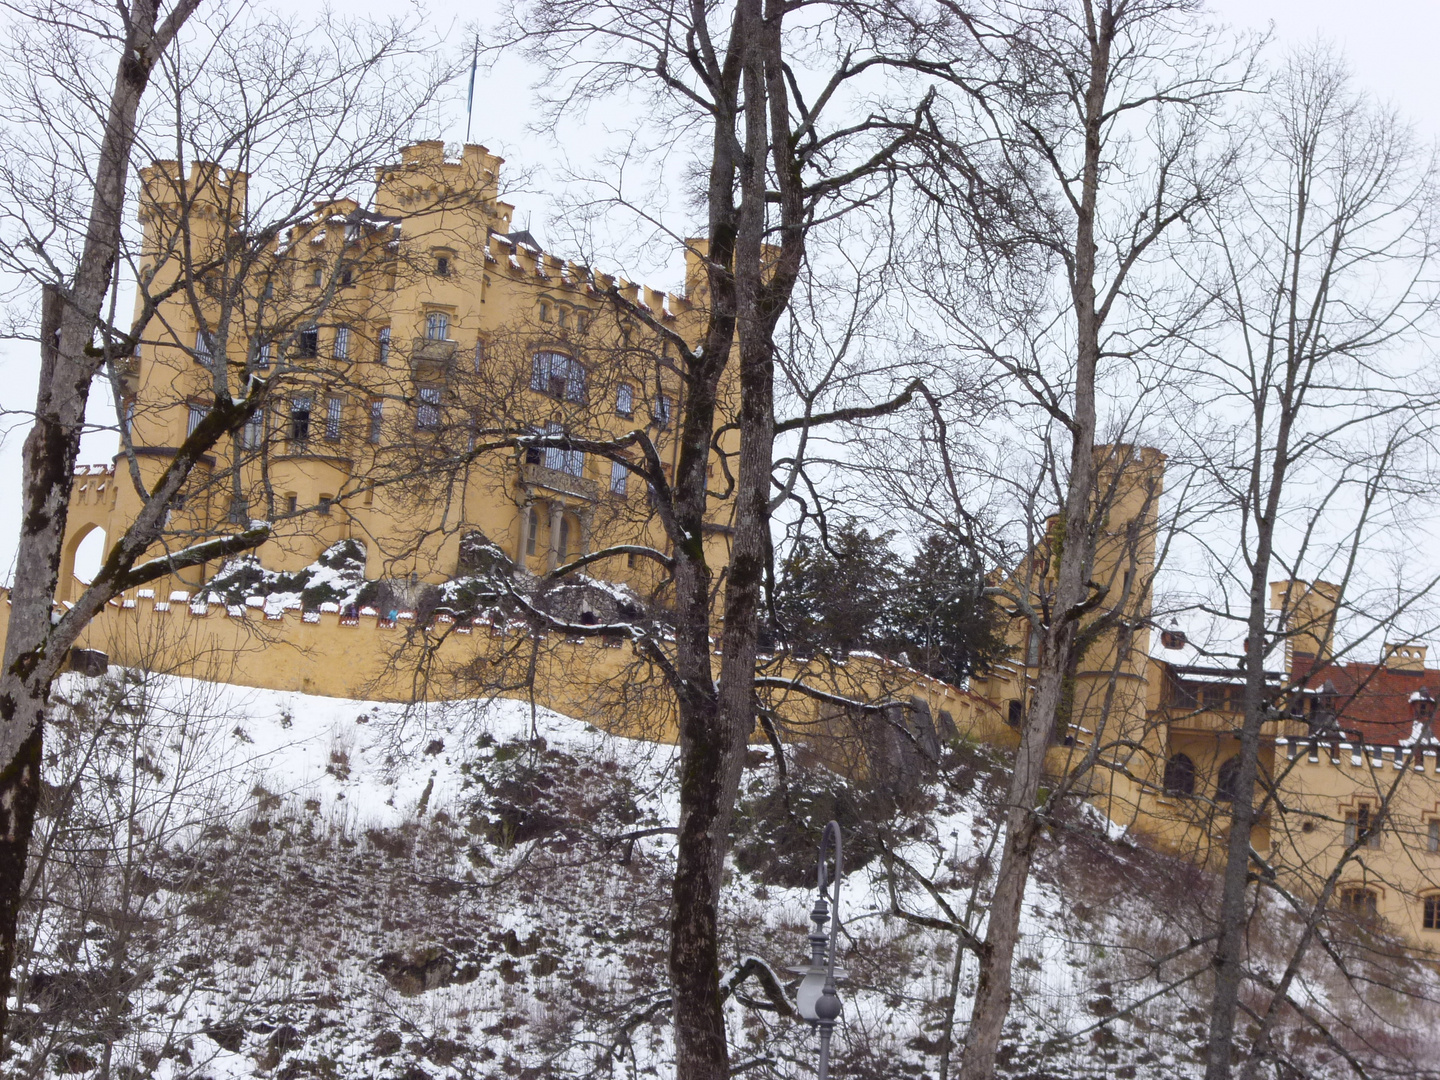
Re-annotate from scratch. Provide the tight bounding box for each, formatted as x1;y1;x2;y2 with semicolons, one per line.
1197;50;1440;1080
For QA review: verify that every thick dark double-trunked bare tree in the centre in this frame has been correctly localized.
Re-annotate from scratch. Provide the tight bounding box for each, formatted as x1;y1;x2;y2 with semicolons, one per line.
472;0;961;1079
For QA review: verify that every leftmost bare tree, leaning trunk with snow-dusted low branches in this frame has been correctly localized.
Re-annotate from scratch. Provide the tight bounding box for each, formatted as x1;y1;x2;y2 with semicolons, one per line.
0;0;438;1048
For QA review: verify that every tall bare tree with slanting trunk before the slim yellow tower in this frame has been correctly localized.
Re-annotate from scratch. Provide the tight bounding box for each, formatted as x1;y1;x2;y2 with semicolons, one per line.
898;0;1248;1080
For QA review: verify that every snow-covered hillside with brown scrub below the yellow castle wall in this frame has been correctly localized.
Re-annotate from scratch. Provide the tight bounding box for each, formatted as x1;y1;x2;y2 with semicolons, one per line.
12;670;1440;1080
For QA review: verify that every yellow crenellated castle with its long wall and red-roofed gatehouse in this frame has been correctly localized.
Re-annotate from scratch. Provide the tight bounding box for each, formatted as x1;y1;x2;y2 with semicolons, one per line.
30;143;1440;950
